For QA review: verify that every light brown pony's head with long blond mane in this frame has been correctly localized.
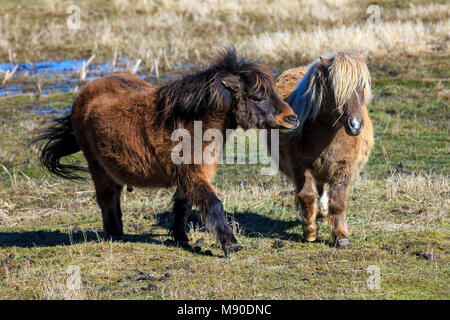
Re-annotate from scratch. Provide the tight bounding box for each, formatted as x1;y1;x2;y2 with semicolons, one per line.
287;52;372;136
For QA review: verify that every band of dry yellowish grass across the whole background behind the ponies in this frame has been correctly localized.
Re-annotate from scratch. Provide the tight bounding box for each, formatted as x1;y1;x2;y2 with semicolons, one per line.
0;0;450;71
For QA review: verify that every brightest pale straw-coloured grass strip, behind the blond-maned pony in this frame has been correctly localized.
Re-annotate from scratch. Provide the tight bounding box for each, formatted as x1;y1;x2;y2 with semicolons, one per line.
244;20;450;63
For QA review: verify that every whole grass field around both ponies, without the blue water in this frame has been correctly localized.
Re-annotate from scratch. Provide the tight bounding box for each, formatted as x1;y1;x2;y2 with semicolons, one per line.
0;0;450;299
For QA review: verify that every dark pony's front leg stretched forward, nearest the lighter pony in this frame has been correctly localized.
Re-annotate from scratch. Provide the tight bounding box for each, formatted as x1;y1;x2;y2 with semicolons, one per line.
185;180;242;255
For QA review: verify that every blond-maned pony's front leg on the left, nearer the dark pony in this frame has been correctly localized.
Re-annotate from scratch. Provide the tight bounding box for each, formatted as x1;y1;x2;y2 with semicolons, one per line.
297;169;317;242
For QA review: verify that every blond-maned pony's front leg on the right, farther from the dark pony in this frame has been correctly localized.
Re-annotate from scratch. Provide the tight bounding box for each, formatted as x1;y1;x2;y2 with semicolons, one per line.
328;178;350;248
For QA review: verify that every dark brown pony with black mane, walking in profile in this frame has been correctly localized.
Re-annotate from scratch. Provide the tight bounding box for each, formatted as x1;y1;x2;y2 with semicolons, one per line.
37;49;298;254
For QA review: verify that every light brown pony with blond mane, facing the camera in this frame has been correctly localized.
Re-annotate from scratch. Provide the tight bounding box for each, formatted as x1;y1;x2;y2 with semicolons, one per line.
269;52;373;247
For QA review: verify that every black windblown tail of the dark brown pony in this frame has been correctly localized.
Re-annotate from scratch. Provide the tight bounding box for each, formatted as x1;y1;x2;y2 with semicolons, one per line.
32;114;87;180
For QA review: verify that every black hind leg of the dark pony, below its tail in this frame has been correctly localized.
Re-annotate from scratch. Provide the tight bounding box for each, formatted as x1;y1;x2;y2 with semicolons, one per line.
88;160;123;241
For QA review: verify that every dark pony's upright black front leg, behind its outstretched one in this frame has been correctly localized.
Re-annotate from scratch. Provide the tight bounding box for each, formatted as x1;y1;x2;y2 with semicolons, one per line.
171;189;192;244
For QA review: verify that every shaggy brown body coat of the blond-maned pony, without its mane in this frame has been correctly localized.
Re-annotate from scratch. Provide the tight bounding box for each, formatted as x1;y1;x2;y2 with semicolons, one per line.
275;53;374;247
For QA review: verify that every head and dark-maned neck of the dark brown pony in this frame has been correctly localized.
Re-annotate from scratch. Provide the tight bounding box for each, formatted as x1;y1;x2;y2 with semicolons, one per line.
159;48;298;130
